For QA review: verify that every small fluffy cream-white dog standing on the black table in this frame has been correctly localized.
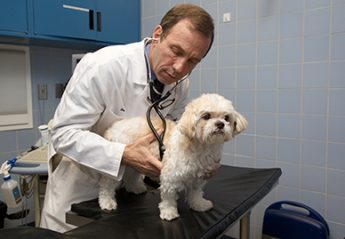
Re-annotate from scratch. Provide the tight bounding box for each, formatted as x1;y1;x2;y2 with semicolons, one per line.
99;94;247;221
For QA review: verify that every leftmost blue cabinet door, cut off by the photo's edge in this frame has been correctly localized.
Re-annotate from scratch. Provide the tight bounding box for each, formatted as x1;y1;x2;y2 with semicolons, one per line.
0;0;28;34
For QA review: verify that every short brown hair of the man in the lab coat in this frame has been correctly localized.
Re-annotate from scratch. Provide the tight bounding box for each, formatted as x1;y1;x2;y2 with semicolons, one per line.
160;3;214;55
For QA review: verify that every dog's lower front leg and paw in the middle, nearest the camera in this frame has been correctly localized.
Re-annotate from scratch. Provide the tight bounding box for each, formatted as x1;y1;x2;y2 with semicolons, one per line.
158;187;180;221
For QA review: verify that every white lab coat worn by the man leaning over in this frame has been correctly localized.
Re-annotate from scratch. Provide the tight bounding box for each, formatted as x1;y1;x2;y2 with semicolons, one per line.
41;39;188;232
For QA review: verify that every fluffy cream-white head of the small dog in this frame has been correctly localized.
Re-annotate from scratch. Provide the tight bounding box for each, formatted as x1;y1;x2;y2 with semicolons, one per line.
178;94;247;144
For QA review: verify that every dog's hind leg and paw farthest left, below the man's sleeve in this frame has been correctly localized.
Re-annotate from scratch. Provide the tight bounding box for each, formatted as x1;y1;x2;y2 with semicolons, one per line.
98;176;119;211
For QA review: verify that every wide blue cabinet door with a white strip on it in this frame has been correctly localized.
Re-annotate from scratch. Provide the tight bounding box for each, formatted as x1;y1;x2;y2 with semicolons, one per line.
33;0;96;39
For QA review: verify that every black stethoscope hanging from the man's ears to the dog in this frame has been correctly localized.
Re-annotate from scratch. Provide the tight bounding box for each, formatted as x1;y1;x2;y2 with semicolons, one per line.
144;38;190;160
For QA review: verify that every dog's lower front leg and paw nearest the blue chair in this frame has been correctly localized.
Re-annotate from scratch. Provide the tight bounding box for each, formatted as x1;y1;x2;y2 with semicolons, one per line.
187;185;213;212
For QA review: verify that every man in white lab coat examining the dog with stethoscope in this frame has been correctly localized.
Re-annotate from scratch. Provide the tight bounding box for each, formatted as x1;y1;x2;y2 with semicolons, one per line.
41;4;214;232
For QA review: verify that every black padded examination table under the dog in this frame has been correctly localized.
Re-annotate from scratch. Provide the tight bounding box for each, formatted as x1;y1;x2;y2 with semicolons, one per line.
0;166;281;239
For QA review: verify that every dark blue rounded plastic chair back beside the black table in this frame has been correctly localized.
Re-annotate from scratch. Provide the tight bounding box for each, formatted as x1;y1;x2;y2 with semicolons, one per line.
262;201;329;239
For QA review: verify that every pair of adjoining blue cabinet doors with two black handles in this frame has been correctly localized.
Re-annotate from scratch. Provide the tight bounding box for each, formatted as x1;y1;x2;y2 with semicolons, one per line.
33;0;140;43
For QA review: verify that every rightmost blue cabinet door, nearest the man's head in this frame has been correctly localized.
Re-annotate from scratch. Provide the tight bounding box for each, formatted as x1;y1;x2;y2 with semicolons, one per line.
96;0;140;43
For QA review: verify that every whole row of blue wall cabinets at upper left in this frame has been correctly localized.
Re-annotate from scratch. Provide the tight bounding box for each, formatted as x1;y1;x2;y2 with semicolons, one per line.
0;0;140;44
